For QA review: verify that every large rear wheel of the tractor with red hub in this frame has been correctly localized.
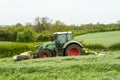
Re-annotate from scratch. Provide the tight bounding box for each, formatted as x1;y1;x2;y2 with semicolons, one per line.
65;44;82;56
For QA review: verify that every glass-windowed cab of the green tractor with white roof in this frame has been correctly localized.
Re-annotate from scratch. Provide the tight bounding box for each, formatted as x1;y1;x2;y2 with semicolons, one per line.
54;32;72;48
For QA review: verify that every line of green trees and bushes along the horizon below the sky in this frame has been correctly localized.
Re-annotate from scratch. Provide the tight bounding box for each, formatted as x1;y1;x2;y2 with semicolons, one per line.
0;17;120;42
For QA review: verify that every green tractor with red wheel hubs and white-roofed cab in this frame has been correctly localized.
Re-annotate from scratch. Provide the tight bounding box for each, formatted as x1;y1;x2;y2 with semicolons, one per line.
35;32;82;58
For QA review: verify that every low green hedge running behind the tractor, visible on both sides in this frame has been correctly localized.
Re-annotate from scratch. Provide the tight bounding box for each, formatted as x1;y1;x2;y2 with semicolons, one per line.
0;42;120;58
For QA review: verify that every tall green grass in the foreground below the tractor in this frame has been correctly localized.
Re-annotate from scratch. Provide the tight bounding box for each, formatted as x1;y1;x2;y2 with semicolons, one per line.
0;51;120;80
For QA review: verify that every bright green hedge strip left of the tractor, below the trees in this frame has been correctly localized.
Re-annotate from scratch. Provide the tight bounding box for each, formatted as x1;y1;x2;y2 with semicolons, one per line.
0;43;40;58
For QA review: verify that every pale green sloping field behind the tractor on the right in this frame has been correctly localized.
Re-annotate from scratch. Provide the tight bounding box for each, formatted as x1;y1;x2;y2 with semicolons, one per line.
74;31;120;46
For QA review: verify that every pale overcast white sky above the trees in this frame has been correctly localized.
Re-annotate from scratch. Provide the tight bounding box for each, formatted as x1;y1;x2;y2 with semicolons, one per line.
0;0;120;25
